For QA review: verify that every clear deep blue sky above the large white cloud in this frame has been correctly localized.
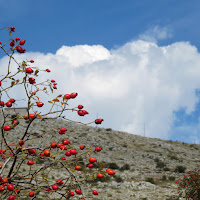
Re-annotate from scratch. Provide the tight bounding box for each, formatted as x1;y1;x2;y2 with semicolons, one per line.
0;0;200;53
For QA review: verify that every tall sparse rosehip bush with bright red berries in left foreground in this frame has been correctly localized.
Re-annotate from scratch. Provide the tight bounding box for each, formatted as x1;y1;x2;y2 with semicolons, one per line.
0;26;115;200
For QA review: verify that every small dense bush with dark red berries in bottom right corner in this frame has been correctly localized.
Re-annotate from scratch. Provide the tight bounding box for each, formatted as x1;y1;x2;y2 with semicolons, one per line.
173;169;200;200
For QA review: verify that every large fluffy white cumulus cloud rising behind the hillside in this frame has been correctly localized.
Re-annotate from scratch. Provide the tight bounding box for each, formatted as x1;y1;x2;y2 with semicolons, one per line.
0;40;200;142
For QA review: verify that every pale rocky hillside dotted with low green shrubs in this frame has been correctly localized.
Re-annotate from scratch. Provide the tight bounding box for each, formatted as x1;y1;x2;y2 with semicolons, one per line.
0;115;200;200
